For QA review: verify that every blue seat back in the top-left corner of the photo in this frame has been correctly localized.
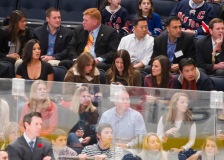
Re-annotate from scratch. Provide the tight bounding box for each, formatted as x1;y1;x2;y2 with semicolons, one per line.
0;0;17;21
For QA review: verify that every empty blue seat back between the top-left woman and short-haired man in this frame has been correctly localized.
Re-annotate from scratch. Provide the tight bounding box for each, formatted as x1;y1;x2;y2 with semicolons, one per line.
17;0;58;22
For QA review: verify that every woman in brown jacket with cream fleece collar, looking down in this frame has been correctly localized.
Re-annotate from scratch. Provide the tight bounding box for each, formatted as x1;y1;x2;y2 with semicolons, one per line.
64;52;100;84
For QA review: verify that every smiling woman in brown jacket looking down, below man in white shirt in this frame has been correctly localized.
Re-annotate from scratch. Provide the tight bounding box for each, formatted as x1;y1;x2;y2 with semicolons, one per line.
105;49;141;86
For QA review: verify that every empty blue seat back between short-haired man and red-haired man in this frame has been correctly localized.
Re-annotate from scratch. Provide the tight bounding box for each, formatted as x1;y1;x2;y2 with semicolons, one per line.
58;0;98;24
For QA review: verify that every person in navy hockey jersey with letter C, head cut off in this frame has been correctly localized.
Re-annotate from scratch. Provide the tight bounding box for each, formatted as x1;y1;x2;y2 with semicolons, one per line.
170;0;215;38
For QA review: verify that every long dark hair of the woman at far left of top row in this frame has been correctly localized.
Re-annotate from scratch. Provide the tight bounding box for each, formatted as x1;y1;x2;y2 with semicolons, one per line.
7;10;26;43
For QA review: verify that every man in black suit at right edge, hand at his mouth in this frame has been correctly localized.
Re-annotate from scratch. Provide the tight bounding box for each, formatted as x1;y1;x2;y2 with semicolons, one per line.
196;18;224;76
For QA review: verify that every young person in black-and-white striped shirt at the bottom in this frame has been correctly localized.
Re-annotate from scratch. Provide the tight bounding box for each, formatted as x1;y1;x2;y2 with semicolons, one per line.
79;123;123;160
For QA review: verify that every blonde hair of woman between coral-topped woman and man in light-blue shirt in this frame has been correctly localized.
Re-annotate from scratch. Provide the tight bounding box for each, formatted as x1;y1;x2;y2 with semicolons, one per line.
70;86;96;113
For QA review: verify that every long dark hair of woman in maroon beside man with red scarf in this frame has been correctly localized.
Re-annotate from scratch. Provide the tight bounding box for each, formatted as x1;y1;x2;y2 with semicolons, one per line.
151;55;171;88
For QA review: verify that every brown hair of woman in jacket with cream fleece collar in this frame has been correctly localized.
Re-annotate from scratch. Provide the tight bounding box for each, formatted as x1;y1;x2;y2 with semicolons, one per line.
76;52;96;78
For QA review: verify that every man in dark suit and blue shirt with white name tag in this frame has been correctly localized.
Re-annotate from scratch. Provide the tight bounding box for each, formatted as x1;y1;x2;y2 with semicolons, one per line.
151;17;195;72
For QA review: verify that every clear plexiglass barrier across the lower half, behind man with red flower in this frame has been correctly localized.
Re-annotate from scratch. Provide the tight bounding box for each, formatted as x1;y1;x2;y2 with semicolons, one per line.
0;79;224;160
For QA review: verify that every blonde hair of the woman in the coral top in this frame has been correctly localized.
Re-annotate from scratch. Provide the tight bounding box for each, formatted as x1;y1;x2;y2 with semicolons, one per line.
29;80;51;111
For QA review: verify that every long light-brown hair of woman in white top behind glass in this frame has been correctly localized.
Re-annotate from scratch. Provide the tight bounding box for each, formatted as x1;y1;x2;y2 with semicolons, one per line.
165;92;192;123
